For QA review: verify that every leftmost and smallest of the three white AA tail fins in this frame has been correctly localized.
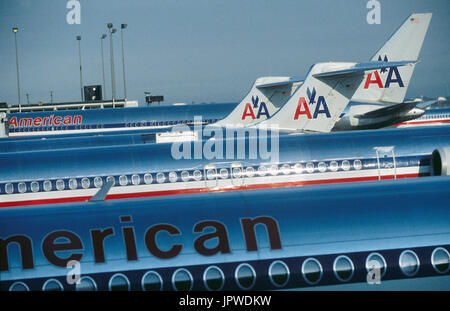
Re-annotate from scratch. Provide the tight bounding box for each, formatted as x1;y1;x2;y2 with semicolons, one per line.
214;77;303;127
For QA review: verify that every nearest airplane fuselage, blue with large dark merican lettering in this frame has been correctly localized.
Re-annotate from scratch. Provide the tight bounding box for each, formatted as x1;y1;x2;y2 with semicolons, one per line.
0;176;450;292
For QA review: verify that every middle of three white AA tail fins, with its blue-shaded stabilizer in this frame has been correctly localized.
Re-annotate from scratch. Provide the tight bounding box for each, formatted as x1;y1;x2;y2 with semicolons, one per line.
255;61;414;132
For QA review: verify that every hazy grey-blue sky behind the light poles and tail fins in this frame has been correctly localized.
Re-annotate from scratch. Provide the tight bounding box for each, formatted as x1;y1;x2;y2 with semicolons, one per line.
0;0;450;104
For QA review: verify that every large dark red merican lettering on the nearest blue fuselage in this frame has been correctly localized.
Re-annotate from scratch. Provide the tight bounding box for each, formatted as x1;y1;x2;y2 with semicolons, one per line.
0;215;282;274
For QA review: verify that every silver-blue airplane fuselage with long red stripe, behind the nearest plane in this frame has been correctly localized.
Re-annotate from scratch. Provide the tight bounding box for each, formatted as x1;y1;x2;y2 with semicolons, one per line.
0;126;450;207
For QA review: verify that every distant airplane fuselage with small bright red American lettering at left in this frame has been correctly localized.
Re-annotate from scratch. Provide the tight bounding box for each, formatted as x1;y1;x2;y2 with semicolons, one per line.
8;103;236;137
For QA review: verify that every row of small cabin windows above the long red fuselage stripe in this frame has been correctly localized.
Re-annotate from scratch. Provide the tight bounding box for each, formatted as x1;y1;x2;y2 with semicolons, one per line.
0;159;362;194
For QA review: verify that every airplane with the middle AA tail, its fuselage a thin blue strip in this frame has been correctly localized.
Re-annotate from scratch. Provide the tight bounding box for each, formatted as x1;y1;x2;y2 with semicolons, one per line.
0;61;413;152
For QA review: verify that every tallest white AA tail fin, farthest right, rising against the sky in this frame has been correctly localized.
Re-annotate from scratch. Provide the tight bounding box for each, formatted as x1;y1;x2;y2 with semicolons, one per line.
352;13;432;103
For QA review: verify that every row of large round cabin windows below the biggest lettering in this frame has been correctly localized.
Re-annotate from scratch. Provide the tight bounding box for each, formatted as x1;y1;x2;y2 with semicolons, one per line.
9;247;450;291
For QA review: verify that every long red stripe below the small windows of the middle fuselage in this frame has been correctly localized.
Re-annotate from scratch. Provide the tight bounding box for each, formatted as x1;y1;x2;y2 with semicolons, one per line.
0;173;430;208
